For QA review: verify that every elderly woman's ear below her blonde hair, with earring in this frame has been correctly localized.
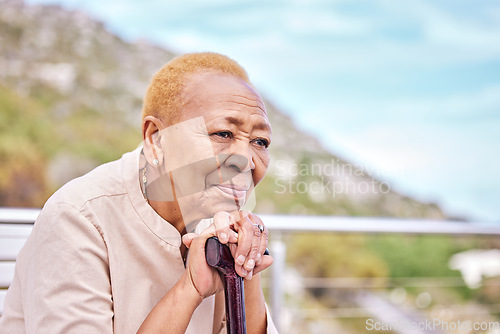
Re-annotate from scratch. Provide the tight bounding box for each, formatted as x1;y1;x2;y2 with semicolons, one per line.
142;116;163;167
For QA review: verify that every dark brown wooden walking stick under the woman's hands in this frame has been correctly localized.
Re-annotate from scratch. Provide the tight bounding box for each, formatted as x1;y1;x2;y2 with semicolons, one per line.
205;237;247;334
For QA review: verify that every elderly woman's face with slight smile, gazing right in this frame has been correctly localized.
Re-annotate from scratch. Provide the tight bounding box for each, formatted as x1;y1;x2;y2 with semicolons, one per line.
161;73;271;223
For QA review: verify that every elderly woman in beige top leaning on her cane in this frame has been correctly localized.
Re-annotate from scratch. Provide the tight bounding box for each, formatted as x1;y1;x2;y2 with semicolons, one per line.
0;53;275;334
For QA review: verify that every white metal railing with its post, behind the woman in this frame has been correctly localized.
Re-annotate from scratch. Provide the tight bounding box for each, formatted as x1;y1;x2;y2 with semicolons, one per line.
0;208;500;329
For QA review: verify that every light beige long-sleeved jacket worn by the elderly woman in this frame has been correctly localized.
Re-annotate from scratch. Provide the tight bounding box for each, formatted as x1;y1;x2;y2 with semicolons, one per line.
0;149;275;334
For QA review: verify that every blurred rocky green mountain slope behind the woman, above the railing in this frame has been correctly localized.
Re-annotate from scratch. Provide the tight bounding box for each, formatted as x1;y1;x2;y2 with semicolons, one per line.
0;0;444;218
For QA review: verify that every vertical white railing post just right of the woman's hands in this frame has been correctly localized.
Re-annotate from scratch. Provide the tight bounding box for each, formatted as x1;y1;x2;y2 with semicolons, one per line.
271;231;286;331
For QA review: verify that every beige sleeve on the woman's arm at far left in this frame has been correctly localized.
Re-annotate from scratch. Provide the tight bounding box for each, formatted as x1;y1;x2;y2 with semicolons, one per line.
22;204;113;334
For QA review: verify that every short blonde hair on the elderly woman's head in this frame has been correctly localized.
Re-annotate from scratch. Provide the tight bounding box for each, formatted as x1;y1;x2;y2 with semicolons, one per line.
142;52;252;124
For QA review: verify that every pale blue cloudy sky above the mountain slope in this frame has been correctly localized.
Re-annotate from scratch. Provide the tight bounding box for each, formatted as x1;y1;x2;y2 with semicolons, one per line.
28;0;500;222
